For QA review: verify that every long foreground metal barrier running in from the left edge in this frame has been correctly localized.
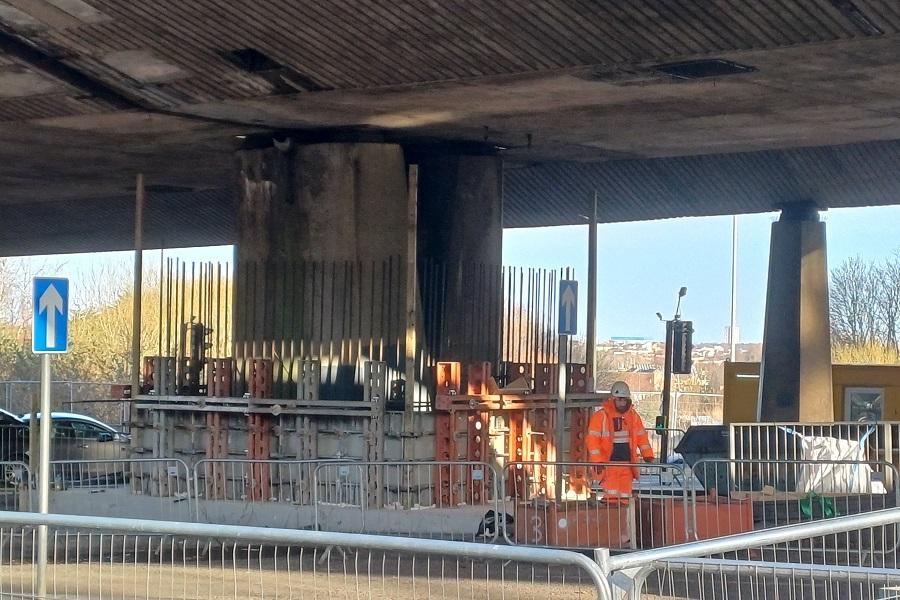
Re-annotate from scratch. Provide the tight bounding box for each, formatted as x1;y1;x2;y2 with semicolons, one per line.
0;512;611;600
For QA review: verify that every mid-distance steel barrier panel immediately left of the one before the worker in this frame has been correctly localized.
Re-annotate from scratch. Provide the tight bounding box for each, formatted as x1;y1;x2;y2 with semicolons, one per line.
313;461;505;542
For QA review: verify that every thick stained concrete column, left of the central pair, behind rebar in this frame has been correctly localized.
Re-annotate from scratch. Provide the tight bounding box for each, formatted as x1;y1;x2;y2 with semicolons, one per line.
233;143;407;399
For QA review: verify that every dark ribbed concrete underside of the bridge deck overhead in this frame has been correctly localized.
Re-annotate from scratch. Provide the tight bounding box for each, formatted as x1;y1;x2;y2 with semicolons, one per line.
0;0;900;255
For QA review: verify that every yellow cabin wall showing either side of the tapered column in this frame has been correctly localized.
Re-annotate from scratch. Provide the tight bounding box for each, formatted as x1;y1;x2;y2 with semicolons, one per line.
723;362;900;423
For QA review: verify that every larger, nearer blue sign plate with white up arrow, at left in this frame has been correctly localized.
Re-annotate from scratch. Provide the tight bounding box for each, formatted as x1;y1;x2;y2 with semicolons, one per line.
31;277;69;354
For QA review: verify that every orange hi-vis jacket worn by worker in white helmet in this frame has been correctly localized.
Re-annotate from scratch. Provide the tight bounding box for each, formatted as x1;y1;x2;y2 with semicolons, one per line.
587;398;653;479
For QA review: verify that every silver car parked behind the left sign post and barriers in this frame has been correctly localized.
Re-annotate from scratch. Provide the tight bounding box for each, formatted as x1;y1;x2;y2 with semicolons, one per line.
19;412;131;483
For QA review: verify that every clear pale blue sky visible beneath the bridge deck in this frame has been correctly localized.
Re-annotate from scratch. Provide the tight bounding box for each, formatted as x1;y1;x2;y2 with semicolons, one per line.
14;206;900;342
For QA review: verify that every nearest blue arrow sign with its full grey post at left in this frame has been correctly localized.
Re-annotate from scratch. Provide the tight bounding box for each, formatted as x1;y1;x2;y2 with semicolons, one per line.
31;277;69;598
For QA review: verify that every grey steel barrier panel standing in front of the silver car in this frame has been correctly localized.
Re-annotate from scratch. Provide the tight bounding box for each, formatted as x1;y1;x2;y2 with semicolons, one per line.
47;458;195;521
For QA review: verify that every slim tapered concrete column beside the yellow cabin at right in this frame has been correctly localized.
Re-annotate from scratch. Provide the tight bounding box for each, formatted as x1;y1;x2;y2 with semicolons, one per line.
758;203;834;422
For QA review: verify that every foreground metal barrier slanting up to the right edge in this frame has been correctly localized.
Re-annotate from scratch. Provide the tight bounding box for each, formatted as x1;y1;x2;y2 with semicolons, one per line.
596;508;900;600
